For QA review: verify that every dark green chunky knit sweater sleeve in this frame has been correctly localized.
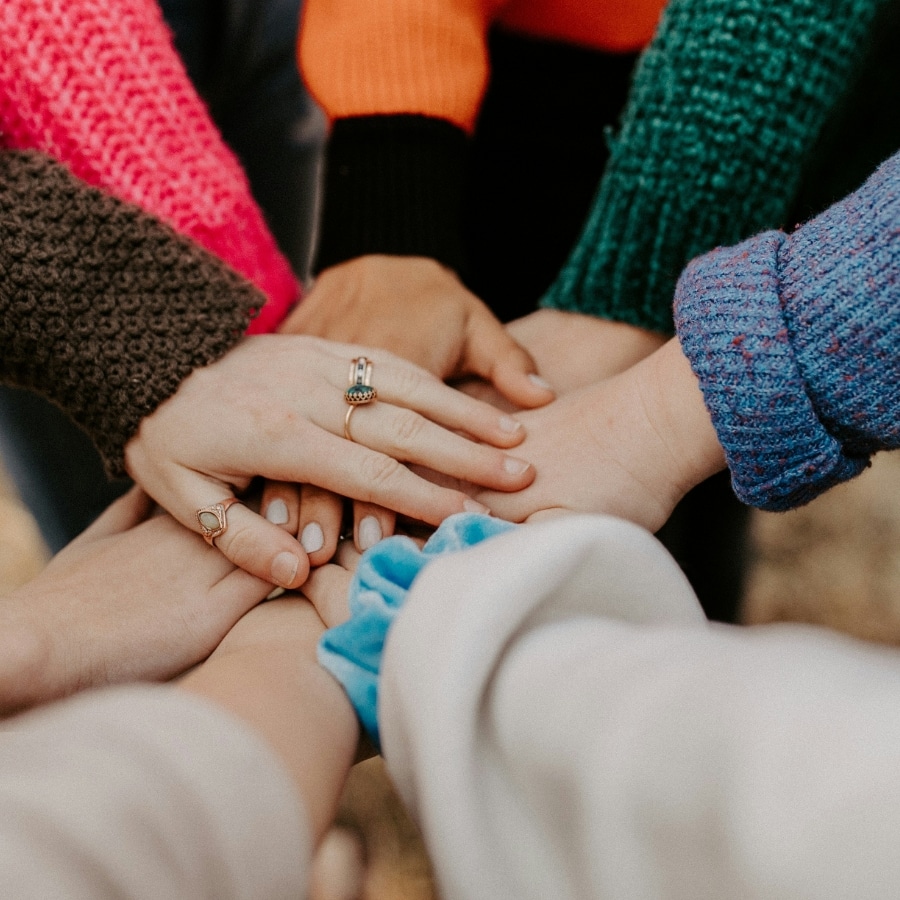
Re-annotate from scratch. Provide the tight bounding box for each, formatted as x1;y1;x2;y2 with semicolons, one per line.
542;0;885;333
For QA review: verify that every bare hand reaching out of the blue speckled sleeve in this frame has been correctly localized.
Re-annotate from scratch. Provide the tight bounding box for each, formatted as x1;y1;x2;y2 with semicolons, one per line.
475;339;725;531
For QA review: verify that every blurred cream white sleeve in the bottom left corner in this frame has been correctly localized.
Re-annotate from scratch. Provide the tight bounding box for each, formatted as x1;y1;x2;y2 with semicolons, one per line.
0;686;310;900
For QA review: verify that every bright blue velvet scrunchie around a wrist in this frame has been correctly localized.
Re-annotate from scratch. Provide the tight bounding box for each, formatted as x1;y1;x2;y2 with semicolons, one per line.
318;513;515;751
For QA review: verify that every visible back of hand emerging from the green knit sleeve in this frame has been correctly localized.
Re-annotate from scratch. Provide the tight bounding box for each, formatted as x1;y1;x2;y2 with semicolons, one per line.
506;309;666;394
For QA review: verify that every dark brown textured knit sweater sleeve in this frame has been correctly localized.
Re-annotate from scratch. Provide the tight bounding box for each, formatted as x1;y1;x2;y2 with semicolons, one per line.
0;152;264;476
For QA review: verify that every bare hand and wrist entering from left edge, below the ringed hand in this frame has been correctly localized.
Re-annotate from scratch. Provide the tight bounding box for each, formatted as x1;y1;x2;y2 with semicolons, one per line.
0;488;271;712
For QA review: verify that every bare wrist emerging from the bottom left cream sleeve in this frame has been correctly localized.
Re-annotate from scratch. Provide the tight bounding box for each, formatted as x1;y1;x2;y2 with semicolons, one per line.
179;599;359;839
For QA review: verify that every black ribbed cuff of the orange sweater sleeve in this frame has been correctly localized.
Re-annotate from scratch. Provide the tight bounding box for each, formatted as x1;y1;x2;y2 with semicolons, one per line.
315;115;468;274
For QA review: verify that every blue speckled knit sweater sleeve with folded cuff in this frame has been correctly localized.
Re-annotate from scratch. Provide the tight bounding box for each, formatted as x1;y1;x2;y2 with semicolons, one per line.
675;154;900;510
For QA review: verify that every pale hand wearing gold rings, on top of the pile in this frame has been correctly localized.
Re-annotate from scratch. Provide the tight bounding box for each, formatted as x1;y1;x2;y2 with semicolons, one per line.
125;335;534;588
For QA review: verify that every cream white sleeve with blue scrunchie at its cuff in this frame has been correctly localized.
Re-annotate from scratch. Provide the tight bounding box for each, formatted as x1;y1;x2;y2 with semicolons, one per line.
380;517;900;900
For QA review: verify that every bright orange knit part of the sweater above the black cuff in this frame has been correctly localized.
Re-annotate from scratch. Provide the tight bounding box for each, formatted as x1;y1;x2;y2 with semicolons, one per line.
298;0;664;133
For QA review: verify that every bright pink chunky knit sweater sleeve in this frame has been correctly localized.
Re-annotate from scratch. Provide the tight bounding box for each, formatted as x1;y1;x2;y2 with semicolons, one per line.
0;0;297;332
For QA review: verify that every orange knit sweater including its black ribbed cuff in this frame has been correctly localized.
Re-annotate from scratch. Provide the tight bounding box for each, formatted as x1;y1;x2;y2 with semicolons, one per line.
299;0;664;271
